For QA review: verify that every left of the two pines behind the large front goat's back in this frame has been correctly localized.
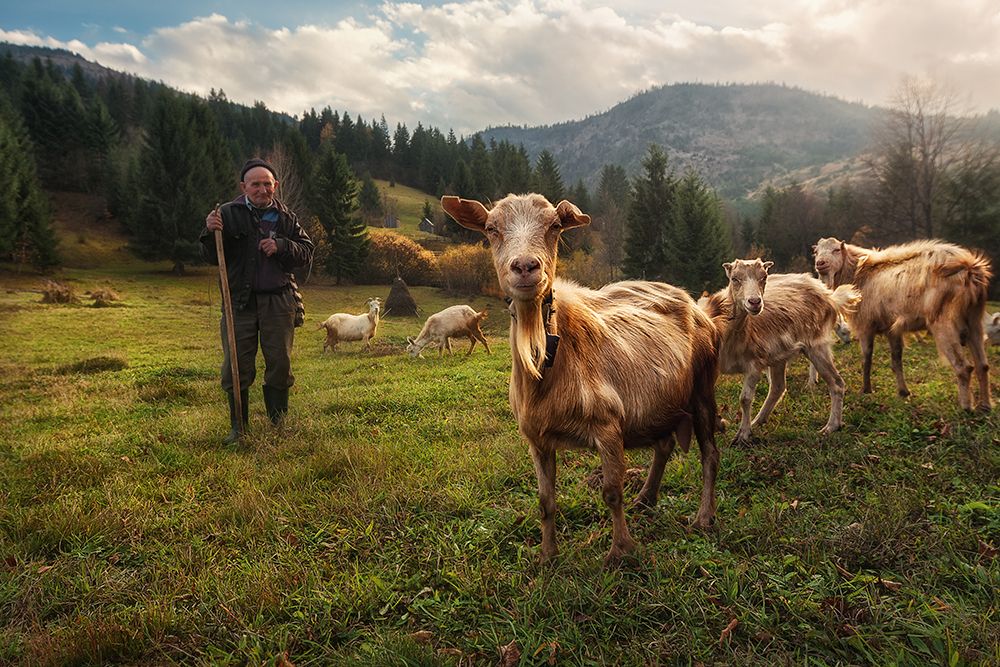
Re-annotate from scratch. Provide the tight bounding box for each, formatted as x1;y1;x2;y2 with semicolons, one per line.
622;144;676;280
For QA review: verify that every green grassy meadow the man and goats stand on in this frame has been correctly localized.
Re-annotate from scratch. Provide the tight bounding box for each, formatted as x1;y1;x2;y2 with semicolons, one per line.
0;240;1000;666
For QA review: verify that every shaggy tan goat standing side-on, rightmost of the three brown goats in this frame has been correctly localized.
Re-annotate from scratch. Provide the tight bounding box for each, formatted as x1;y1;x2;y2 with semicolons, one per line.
813;238;993;410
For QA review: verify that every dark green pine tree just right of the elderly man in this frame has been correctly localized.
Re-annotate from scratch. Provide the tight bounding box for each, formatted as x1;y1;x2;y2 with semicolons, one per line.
311;142;368;285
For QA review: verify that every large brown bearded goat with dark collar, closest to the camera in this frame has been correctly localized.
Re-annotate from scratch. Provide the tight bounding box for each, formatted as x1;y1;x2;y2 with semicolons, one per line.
441;194;719;564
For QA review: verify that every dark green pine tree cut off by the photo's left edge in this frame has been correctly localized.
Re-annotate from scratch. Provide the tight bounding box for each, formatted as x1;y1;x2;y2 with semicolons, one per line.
0;96;59;269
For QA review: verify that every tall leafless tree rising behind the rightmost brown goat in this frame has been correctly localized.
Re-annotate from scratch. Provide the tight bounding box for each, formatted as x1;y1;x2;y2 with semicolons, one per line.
868;77;998;238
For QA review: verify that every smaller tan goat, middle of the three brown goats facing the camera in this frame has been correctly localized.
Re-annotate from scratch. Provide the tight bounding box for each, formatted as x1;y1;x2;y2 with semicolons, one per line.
704;259;858;444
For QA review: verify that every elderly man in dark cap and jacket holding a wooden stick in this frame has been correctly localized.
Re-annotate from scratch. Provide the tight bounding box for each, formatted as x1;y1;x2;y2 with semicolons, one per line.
199;158;313;444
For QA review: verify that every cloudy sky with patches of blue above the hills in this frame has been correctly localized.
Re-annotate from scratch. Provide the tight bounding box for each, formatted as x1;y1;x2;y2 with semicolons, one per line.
0;0;1000;134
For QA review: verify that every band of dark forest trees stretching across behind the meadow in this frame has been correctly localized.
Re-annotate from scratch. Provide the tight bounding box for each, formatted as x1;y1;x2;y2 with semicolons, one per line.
0;52;1000;292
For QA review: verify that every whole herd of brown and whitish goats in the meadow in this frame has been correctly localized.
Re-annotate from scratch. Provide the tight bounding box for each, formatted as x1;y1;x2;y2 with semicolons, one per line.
320;194;1000;563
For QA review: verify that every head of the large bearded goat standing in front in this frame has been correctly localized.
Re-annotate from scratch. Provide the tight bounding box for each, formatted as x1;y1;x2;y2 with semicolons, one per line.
441;194;590;301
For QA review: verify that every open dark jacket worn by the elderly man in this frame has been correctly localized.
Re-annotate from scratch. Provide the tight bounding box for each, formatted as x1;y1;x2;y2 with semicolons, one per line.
198;196;313;310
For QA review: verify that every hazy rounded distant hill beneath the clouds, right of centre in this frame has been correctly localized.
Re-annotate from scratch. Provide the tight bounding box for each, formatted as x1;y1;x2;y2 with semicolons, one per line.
483;84;882;197
